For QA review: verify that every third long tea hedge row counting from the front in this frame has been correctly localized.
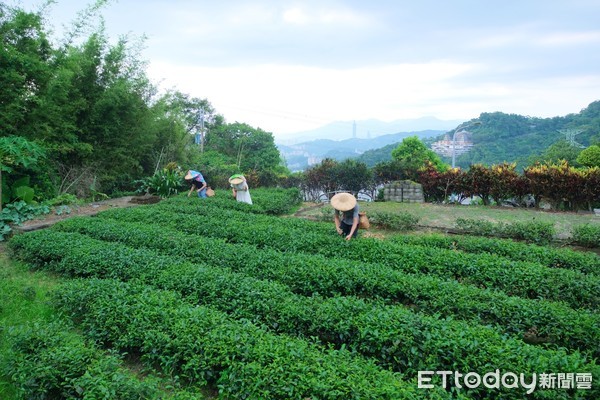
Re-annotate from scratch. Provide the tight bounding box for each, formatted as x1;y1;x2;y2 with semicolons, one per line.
43;218;600;351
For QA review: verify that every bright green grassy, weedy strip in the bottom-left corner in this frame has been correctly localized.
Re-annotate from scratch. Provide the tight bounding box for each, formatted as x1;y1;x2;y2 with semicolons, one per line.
0;246;216;400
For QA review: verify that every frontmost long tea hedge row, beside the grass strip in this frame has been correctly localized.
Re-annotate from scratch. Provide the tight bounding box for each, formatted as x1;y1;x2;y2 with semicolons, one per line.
50;279;426;399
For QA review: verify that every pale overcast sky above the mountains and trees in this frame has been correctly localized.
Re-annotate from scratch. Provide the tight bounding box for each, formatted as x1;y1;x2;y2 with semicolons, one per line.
9;0;600;138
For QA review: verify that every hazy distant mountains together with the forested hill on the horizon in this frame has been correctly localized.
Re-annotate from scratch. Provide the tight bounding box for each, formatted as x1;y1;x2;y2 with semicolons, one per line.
278;101;600;171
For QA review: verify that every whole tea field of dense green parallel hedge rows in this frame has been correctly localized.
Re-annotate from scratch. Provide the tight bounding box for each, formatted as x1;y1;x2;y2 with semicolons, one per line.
9;192;600;399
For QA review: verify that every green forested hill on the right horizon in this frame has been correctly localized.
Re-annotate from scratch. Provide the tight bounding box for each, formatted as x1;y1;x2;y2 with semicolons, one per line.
358;101;600;168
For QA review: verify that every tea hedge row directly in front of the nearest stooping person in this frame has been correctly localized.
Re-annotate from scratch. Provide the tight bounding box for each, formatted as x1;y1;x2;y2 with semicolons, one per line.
92;198;598;308
